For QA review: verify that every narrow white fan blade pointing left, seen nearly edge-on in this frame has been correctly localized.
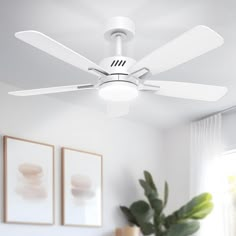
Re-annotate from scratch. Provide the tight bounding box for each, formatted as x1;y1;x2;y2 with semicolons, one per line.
8;84;95;96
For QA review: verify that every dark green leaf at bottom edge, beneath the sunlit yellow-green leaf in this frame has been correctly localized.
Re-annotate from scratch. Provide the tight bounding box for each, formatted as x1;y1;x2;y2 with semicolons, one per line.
165;221;200;236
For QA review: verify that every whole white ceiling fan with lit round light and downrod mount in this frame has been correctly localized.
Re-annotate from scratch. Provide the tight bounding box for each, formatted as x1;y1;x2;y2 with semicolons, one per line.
9;17;227;113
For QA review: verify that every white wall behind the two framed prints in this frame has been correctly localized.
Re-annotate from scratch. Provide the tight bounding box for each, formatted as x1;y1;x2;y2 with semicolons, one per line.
0;84;162;236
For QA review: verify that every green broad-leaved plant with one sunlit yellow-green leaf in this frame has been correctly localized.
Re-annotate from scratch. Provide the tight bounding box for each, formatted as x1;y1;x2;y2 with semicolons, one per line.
120;171;213;236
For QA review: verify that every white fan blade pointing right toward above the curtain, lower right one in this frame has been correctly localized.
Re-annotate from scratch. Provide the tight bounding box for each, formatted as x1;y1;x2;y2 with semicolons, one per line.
144;80;227;101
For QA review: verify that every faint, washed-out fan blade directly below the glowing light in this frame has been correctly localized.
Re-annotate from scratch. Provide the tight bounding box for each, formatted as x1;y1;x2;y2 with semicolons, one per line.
107;102;130;118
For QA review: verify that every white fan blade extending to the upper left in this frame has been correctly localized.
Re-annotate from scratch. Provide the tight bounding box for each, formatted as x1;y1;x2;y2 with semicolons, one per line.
15;30;106;75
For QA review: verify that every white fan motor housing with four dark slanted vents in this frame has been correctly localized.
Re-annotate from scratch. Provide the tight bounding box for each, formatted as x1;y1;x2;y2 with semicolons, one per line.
99;56;136;75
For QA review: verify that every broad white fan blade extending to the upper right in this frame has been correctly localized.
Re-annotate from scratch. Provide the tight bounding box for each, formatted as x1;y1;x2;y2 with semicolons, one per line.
129;25;224;75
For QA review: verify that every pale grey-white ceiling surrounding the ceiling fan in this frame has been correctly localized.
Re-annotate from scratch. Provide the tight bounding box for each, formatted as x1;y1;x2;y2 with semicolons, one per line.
0;0;236;127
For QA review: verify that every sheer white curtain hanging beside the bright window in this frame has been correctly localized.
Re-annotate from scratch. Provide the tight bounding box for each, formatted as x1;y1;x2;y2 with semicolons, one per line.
190;114;225;236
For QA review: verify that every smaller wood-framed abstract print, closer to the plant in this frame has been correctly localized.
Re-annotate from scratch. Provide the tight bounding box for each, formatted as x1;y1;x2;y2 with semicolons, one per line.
62;148;102;227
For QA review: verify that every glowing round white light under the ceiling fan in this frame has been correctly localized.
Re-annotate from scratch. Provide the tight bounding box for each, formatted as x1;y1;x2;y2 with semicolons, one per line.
99;81;138;102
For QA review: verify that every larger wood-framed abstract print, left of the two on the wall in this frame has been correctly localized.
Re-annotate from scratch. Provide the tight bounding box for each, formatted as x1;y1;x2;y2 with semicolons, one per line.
3;136;54;225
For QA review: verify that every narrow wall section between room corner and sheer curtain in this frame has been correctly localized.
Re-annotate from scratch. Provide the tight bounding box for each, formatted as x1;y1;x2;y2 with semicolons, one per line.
161;125;190;212
